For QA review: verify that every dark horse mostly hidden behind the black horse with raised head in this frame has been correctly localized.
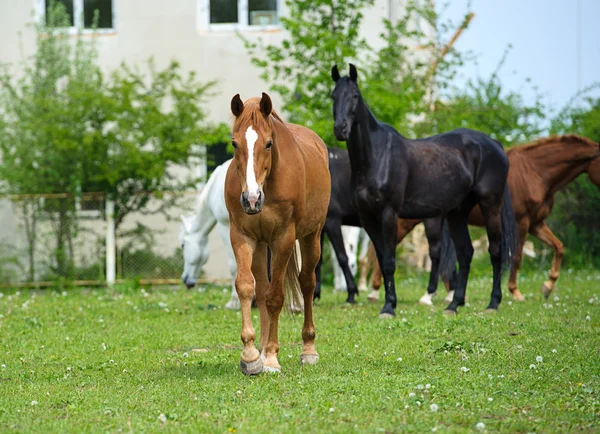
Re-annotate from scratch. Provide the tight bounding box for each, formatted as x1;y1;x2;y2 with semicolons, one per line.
314;148;456;303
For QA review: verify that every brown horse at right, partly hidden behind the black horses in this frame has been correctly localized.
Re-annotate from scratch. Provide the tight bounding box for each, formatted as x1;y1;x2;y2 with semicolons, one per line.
361;134;600;304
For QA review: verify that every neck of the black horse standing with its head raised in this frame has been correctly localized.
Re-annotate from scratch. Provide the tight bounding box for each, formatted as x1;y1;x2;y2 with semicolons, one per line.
346;95;378;174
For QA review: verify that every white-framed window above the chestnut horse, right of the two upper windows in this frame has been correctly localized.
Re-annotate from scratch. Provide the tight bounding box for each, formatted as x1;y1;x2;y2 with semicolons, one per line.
197;0;283;31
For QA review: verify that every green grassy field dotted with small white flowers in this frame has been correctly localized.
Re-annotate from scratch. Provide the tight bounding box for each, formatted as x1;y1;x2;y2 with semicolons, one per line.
0;262;600;433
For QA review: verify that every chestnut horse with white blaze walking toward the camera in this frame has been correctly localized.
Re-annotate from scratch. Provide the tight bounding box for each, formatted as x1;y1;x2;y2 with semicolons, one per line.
225;93;331;375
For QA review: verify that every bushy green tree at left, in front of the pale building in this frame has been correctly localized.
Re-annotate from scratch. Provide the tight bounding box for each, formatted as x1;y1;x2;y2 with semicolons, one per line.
0;3;229;277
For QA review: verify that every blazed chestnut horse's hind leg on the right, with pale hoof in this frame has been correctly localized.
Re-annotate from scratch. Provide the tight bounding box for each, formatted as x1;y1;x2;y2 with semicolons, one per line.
298;234;321;365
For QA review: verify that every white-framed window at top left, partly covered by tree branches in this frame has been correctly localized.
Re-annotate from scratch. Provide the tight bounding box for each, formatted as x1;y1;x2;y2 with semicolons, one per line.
36;0;116;33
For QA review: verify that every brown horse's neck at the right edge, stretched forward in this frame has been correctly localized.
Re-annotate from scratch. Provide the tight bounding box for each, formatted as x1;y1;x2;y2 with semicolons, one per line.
524;141;598;195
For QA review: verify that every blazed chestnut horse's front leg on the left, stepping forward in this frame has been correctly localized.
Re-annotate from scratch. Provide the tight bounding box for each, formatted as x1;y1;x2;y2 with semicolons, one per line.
231;225;263;375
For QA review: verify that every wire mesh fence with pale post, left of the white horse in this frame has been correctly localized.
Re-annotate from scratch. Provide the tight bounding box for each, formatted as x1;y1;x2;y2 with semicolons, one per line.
0;192;198;287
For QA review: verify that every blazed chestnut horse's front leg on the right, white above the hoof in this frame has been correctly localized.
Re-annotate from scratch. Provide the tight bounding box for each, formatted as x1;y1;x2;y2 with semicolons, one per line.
263;230;298;372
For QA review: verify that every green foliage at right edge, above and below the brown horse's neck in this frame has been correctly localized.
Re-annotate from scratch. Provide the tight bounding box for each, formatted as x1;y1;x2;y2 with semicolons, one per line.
549;94;600;266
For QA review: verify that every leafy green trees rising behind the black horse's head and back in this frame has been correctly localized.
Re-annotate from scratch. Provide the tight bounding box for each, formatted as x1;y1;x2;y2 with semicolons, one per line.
246;0;544;146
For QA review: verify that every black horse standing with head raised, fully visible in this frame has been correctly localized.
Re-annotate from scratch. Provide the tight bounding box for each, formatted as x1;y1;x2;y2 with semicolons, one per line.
331;64;517;317
